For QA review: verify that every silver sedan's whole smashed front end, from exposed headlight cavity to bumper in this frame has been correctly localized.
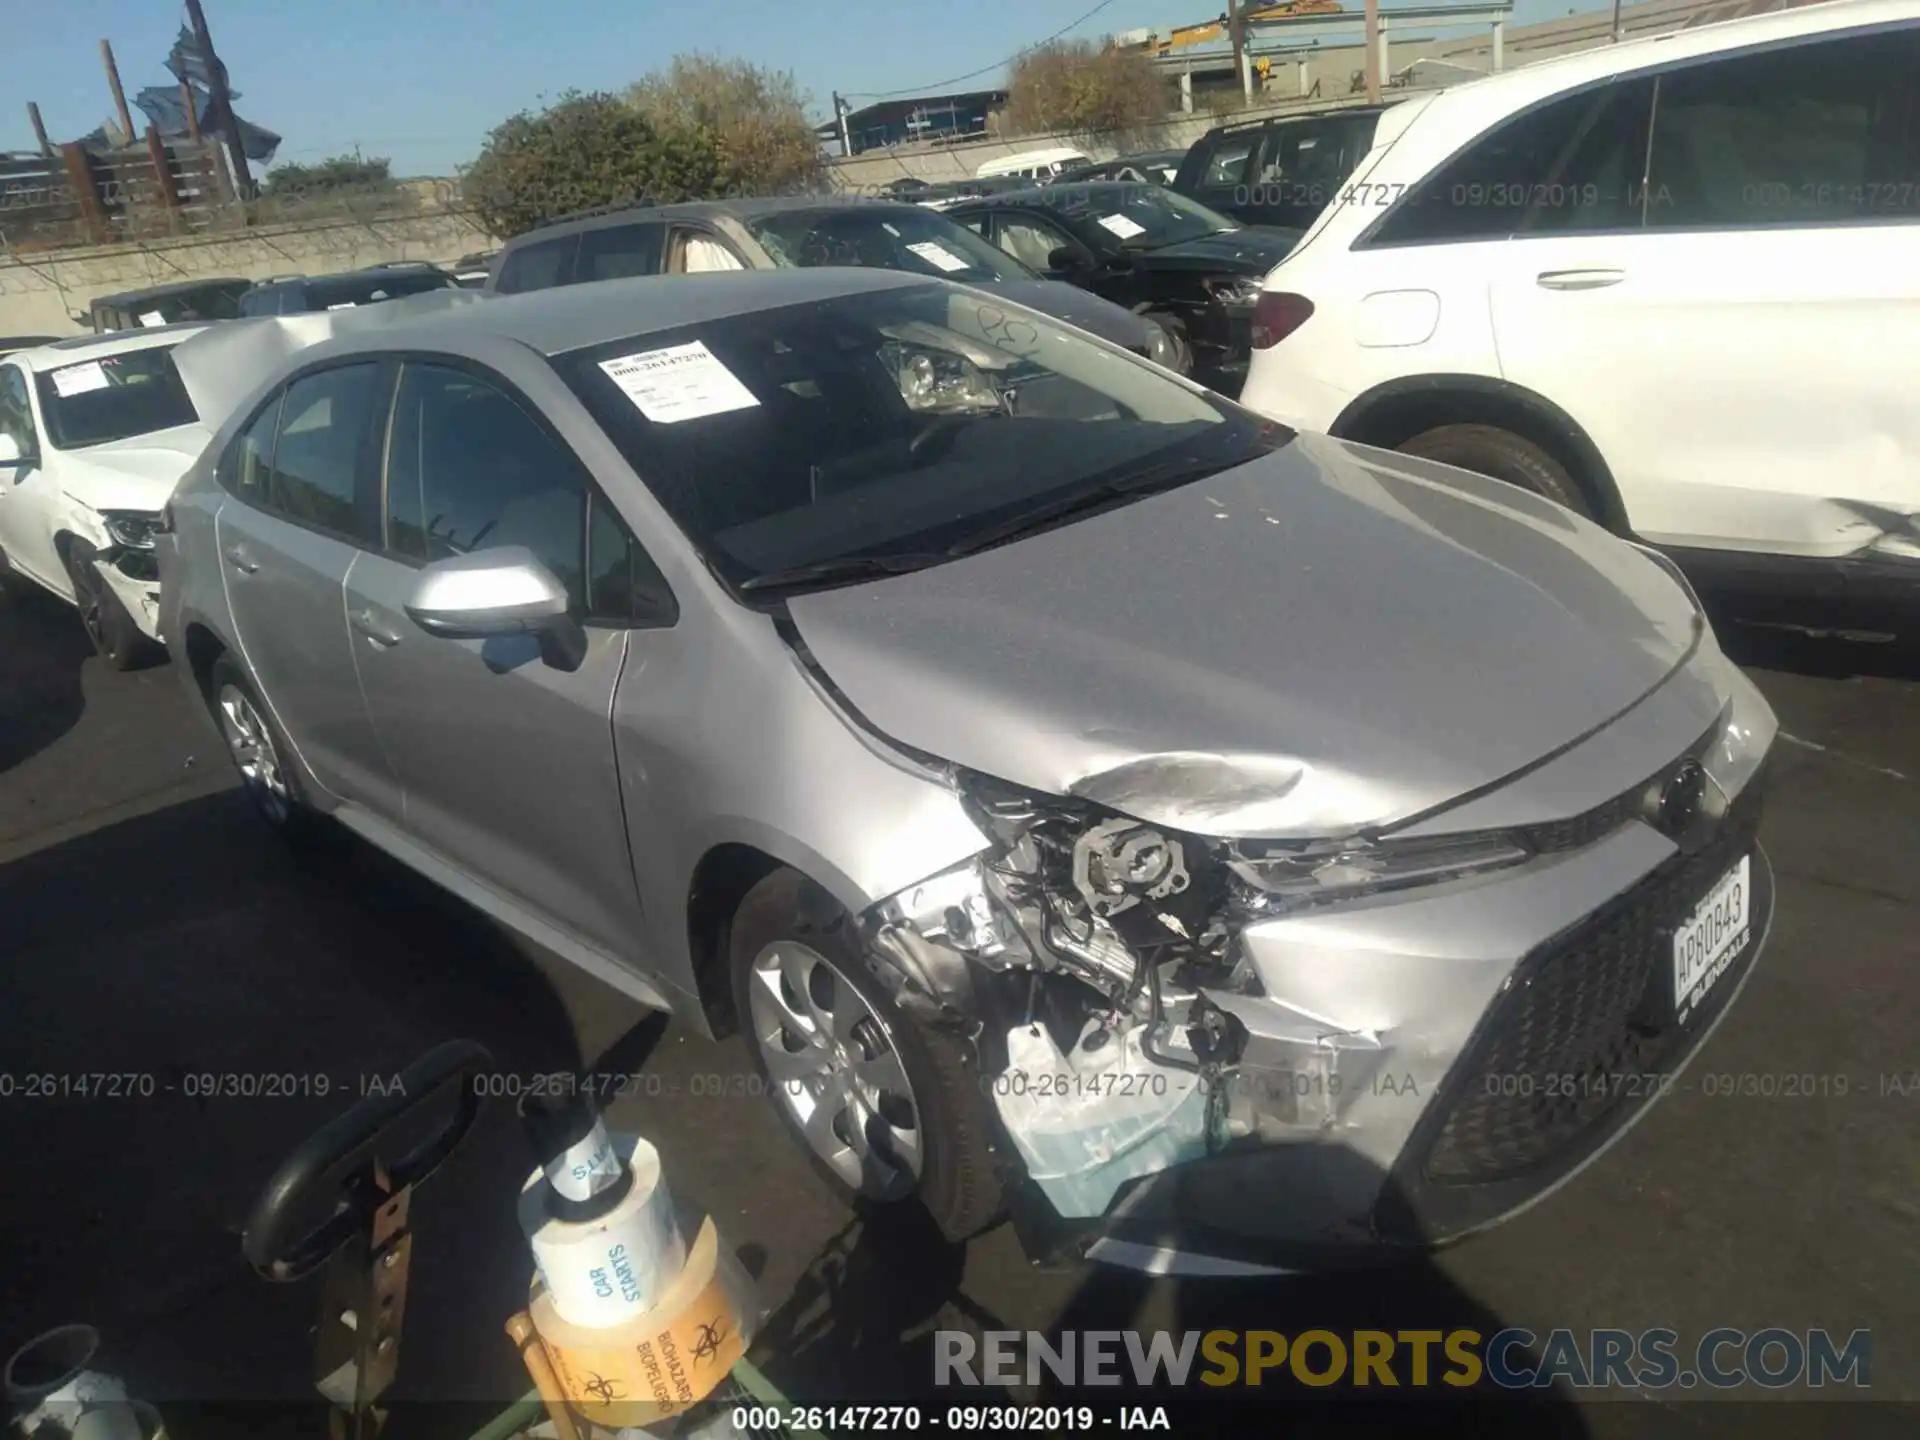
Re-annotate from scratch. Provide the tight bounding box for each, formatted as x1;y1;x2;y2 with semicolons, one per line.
862;702;1772;1267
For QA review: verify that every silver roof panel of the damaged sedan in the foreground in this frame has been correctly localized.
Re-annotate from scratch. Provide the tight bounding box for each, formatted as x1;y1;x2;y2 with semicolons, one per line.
288;267;939;355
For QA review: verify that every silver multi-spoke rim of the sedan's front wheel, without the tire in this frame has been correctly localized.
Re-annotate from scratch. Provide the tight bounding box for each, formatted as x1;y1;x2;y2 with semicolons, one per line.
749;941;924;1200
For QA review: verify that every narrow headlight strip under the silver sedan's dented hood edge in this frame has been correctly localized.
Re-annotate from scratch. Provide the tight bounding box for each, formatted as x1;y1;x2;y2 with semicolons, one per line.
1227;831;1532;912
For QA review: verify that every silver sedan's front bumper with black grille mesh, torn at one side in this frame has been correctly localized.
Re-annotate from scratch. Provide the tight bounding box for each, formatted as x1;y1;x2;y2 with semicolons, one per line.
1014;637;1774;1275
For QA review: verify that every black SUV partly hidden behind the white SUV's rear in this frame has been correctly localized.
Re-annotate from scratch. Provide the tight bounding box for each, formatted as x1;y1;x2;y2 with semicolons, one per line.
1173;106;1386;230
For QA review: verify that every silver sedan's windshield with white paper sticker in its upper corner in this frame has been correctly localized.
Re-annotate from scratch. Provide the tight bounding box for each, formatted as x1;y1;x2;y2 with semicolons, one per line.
555;284;1290;589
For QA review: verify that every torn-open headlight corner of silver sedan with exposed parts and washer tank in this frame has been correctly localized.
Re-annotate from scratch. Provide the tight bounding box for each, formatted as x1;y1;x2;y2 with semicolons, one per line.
864;776;1466;1244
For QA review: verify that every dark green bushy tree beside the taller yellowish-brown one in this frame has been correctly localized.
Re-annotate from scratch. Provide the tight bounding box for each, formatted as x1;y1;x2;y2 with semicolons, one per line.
461;90;722;238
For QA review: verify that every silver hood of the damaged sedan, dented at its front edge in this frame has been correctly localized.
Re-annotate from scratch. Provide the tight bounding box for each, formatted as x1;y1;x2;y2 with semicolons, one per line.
789;436;1699;839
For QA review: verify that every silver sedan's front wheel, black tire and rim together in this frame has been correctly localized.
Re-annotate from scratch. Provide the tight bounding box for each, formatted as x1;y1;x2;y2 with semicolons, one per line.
728;870;1000;1240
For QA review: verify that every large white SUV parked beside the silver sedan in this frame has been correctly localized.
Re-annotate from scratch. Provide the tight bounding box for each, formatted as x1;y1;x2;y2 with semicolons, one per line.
1242;0;1920;614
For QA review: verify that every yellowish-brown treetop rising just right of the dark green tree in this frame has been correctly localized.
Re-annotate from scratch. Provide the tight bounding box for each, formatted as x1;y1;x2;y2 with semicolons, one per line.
626;56;826;196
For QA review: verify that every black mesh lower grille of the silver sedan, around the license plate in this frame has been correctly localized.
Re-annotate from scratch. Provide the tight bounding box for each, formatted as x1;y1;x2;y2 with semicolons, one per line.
1423;776;1763;1185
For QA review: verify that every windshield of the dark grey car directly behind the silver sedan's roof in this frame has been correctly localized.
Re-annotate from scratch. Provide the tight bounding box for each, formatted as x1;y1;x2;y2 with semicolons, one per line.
747;207;1033;284
